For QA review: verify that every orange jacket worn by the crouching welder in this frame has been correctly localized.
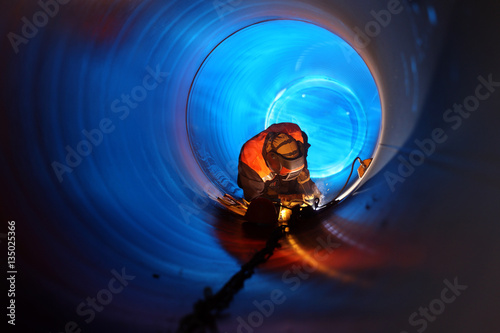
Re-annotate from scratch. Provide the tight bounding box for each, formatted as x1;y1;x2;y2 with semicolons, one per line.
238;123;307;199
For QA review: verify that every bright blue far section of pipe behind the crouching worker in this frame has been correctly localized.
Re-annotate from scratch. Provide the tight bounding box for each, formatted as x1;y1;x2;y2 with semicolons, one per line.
187;20;381;200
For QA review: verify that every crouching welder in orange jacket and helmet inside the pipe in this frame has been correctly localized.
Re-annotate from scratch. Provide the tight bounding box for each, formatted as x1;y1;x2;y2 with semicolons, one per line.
238;123;321;205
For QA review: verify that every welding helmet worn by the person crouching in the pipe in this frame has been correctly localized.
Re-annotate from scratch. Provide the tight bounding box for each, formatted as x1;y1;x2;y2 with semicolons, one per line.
266;133;305;181
